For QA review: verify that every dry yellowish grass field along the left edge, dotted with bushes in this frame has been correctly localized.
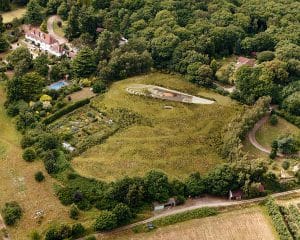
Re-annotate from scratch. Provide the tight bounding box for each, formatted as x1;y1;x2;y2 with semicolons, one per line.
0;83;68;239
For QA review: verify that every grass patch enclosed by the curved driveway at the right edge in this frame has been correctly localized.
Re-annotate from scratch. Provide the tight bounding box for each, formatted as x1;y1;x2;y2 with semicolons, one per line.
256;117;300;148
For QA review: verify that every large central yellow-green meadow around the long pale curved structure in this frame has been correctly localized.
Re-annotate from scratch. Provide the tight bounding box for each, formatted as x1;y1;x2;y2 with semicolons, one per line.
73;73;240;180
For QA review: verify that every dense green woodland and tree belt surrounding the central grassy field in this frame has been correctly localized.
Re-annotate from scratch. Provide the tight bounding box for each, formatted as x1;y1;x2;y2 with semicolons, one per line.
0;0;300;237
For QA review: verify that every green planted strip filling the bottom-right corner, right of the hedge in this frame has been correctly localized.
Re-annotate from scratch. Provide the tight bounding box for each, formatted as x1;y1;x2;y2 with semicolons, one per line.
280;205;300;239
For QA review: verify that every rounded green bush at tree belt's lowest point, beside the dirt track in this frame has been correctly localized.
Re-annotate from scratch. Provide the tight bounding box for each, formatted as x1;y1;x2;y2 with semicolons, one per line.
94;211;117;231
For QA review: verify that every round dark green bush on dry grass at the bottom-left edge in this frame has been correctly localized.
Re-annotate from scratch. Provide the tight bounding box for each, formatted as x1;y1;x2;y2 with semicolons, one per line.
2;202;22;226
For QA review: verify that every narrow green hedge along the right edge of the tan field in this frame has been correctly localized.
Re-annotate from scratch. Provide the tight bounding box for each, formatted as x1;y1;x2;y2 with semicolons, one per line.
265;198;293;240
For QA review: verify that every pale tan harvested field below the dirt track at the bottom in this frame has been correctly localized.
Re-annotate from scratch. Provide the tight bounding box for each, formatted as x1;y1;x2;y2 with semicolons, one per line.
98;207;278;240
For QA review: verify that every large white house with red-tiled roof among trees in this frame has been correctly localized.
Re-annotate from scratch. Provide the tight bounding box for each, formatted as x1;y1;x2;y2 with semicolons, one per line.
24;26;66;57
